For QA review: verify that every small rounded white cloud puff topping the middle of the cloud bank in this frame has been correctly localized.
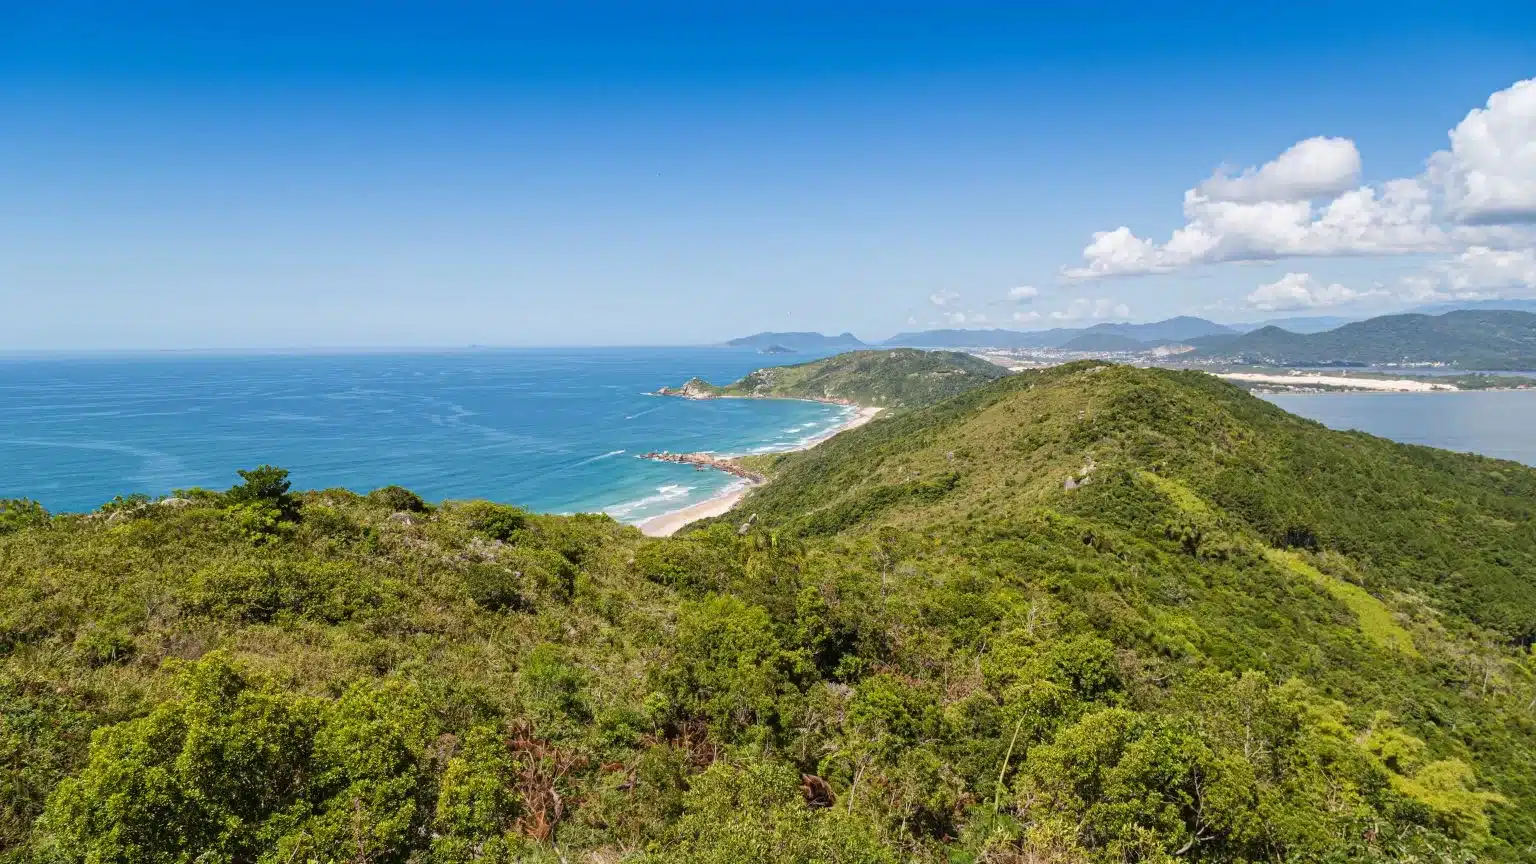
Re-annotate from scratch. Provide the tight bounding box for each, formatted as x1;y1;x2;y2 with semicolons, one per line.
1195;137;1359;203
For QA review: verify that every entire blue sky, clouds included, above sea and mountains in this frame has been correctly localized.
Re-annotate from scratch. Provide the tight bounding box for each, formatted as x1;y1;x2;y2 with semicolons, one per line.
0;0;1536;349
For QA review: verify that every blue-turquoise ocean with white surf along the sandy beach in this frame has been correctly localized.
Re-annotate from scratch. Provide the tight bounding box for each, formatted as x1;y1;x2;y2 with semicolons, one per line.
0;349;848;521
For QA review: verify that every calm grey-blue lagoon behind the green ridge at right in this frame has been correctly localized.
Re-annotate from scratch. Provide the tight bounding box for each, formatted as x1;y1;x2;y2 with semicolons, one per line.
1264;390;1536;466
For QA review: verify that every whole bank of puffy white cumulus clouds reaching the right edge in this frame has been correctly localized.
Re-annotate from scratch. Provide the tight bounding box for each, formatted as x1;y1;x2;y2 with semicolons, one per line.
1063;78;1536;280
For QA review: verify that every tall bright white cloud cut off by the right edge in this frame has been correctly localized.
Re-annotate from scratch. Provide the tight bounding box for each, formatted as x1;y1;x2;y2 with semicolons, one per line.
1430;78;1536;224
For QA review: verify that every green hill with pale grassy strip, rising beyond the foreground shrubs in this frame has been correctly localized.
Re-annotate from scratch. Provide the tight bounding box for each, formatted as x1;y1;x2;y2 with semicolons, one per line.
718;363;1536;838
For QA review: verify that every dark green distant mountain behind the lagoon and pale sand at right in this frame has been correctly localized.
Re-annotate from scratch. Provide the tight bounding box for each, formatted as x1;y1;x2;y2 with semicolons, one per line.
1193;311;1536;371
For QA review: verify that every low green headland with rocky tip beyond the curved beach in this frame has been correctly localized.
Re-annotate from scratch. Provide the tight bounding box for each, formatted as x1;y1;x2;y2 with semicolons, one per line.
662;347;1008;407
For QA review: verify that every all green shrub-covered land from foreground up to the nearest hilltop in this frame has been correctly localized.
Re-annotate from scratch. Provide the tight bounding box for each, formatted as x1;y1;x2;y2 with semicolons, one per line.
0;364;1536;864
